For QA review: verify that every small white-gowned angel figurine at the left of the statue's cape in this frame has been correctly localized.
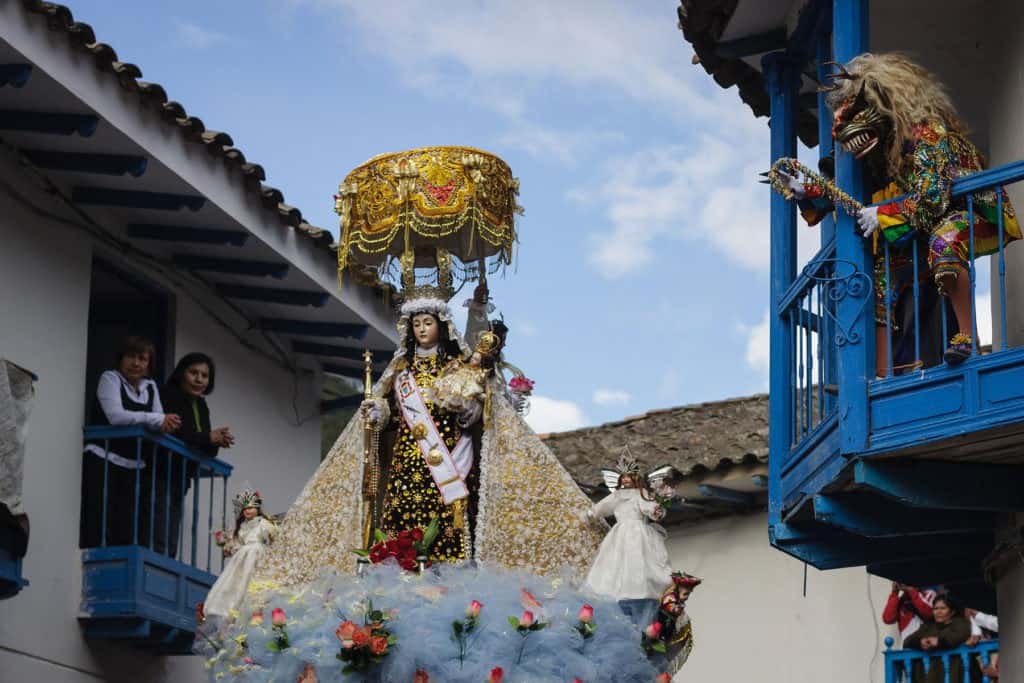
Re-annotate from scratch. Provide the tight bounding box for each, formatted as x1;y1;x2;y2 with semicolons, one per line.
204;485;278;616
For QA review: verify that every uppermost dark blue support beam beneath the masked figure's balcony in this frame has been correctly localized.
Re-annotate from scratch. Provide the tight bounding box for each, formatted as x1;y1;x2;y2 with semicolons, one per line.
853;460;1024;512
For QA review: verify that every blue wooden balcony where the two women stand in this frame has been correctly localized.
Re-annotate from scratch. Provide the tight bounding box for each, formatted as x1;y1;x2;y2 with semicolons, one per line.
79;427;231;653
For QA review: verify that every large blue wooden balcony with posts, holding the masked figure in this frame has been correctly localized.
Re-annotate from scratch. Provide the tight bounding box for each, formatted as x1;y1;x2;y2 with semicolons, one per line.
762;0;1024;607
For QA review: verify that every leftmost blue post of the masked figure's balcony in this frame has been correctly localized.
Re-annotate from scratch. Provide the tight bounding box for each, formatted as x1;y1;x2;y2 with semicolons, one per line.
761;52;800;524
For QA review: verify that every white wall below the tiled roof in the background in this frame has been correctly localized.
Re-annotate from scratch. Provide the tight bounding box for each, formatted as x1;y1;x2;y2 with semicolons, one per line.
669;513;896;683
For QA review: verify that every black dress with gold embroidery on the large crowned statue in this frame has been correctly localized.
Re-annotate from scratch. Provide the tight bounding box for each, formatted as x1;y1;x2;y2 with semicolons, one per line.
381;354;478;562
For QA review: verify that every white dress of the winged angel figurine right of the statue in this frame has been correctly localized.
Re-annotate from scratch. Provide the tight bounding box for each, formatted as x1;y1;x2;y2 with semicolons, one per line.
585;488;672;600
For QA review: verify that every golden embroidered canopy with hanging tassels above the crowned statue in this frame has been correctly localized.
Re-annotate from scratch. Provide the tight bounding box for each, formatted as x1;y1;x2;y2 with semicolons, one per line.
335;146;521;290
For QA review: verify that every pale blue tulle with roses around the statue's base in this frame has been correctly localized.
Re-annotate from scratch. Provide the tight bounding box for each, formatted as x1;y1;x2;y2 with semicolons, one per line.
197;564;658;683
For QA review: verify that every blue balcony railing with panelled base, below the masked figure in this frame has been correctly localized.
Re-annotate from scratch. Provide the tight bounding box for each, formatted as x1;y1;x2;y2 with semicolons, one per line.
771;161;1024;507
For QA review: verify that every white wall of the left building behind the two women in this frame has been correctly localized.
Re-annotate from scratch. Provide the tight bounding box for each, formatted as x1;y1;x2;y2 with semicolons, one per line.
0;149;319;682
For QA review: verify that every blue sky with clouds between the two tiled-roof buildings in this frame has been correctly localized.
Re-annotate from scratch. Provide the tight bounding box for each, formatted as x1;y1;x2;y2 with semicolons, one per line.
71;0;794;431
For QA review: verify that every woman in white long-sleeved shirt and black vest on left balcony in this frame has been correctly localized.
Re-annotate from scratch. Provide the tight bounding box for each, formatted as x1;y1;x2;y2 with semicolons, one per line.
79;337;181;548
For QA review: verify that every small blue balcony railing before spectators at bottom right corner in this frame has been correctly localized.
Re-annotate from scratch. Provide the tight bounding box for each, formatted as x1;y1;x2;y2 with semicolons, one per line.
885;638;999;683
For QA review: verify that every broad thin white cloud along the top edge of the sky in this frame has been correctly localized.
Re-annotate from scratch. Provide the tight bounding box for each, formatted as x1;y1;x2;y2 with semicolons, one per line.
297;0;720;116
